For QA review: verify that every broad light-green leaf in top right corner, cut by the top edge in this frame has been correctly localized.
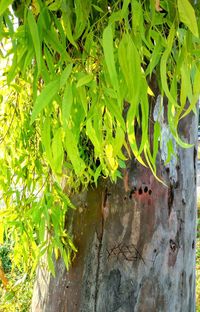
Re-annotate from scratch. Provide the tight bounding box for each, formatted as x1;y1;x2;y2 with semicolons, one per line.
178;0;199;37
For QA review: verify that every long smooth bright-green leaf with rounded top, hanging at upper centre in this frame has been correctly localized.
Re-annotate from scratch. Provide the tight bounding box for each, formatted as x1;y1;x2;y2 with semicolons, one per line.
103;25;119;91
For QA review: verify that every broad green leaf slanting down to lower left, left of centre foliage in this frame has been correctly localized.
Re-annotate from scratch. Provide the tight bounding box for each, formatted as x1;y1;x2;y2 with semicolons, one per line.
31;79;60;124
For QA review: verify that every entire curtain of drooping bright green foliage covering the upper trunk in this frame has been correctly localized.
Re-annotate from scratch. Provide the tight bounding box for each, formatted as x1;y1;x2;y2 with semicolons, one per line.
0;0;200;272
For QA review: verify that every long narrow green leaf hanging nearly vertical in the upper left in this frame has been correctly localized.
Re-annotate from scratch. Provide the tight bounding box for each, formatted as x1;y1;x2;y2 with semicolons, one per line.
27;11;42;73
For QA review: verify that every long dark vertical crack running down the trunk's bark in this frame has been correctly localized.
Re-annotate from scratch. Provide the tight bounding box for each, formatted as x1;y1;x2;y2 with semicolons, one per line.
94;188;110;312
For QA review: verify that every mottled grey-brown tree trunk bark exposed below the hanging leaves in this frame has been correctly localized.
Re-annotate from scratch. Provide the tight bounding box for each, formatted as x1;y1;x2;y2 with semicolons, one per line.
32;110;197;312
